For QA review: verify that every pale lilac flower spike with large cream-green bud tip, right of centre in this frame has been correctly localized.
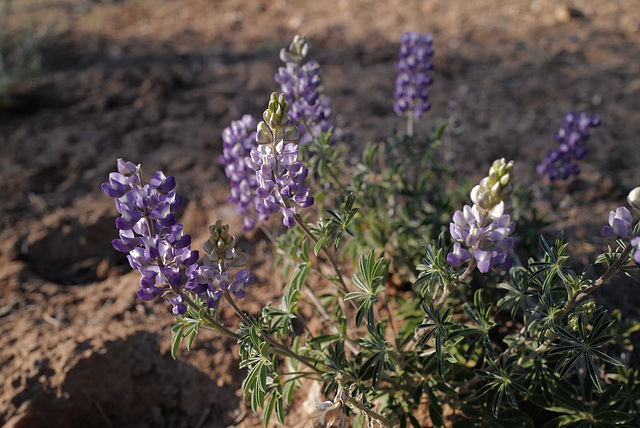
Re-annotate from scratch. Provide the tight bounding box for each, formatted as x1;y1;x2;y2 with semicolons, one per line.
447;159;515;273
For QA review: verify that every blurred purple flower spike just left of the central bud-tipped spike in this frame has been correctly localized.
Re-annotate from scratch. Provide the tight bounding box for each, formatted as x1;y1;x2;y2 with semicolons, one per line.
220;115;268;232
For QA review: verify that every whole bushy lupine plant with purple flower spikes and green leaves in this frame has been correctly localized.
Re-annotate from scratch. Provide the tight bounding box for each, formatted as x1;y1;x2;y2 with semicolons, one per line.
102;33;640;427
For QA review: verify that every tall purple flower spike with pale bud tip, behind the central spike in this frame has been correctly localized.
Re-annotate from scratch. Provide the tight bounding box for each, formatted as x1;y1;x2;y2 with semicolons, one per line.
274;35;333;144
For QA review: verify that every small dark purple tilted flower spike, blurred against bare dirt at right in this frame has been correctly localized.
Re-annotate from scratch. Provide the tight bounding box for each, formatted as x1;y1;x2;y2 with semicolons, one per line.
536;112;600;181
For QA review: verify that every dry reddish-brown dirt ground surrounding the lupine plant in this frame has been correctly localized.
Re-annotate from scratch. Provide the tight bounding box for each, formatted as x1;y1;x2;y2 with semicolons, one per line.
0;0;640;427
